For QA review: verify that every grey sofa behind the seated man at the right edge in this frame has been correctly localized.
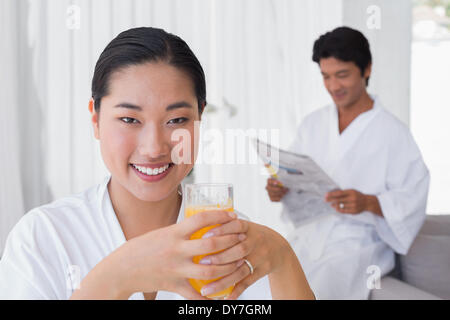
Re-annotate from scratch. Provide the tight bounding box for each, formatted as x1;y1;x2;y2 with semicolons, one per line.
369;215;450;300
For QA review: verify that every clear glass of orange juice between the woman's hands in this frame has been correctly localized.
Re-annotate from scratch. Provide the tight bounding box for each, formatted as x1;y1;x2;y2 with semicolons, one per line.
183;183;234;300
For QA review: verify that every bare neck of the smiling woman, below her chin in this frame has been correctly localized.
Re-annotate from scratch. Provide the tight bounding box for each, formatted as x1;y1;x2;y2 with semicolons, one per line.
107;177;182;240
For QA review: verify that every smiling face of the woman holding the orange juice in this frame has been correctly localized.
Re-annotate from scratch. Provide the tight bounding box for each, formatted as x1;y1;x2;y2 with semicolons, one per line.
90;61;200;202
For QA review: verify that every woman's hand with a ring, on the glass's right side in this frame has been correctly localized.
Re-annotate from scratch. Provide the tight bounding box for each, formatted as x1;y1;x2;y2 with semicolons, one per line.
195;219;314;299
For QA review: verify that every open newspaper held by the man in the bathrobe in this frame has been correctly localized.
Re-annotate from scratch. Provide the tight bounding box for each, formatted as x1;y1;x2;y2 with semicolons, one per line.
253;139;340;226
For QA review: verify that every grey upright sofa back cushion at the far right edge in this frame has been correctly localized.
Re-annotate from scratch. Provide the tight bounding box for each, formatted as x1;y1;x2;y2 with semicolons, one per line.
400;215;450;299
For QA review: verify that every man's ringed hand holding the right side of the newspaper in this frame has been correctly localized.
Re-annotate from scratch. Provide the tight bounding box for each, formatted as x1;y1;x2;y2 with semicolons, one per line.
325;189;383;216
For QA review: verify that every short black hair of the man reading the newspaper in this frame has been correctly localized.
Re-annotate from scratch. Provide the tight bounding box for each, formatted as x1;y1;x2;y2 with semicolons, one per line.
312;27;372;86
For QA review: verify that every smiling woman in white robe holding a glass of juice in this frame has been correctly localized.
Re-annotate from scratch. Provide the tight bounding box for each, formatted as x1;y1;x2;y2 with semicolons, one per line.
0;28;314;299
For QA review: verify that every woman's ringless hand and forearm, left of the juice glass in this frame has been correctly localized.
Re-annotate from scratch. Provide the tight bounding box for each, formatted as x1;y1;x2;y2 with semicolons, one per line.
73;211;243;299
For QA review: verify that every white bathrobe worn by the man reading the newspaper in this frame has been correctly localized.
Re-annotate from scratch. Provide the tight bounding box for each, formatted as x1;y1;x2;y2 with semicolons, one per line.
282;97;430;299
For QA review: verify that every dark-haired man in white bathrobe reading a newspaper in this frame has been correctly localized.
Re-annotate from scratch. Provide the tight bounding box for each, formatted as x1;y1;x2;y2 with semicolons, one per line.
266;27;429;299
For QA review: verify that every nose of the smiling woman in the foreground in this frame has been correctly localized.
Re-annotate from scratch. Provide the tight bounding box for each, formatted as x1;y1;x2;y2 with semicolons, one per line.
138;125;170;159
